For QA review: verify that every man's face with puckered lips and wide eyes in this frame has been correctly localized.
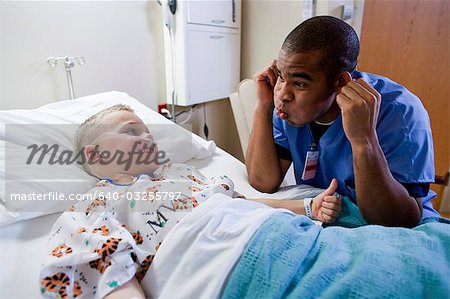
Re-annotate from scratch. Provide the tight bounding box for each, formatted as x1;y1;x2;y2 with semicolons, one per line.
274;50;337;126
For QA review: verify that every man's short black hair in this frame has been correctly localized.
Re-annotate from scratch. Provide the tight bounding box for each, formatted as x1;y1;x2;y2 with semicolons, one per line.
281;16;359;78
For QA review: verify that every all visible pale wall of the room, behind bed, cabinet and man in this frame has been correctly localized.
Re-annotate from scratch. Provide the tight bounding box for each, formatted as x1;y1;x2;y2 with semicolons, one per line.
0;0;362;164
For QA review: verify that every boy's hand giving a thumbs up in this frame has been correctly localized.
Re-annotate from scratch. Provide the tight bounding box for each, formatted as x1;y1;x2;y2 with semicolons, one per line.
311;179;341;223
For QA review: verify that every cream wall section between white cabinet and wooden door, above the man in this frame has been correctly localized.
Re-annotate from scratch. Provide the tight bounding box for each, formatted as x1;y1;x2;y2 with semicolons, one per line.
241;0;364;79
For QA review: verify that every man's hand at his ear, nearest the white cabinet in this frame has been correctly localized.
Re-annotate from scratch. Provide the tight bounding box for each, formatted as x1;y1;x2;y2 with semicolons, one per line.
253;60;278;111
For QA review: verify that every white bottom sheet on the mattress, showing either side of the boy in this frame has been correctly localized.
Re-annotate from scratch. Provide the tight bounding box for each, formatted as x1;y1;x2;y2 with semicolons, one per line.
0;149;264;299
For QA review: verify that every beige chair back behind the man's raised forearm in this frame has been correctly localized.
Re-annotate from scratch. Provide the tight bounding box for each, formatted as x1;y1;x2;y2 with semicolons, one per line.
230;79;295;186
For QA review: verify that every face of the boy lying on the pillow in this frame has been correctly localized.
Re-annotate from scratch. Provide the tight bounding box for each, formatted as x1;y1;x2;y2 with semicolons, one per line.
88;111;160;179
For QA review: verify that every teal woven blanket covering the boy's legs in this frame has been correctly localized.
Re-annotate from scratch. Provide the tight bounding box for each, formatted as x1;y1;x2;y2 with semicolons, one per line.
222;213;450;299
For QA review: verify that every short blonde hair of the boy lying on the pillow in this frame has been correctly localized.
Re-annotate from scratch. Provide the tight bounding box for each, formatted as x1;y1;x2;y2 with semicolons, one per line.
74;104;134;176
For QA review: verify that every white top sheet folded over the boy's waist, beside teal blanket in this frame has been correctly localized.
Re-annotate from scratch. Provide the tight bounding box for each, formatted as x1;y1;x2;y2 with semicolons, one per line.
142;194;291;299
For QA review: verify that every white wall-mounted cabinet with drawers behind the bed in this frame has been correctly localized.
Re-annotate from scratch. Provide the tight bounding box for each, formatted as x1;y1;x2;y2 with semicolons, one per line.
162;0;241;106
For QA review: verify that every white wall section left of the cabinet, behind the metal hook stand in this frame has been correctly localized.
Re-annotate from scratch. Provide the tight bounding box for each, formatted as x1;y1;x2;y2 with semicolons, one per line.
0;1;165;109
